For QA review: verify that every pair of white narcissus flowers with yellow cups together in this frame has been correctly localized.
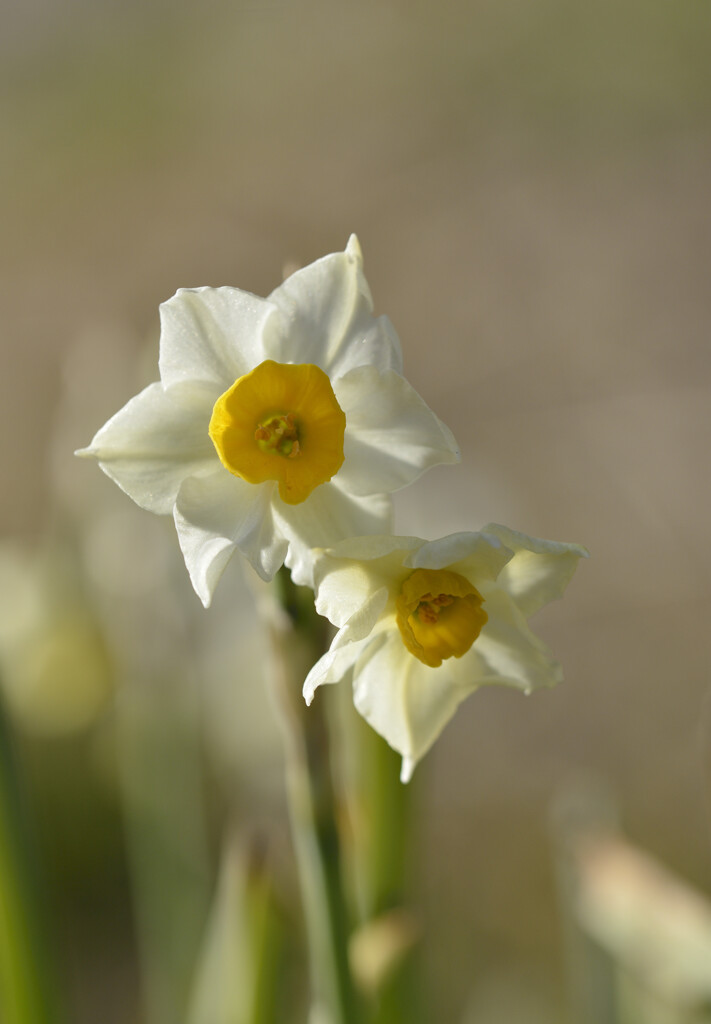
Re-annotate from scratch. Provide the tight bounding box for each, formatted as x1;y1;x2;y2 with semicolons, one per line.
78;236;586;779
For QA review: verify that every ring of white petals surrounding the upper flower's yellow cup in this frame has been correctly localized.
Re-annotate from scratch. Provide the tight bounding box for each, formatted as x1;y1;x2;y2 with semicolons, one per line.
78;236;458;605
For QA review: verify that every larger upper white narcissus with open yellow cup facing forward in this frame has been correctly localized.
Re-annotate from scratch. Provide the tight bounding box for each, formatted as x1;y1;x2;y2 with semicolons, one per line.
78;236;459;606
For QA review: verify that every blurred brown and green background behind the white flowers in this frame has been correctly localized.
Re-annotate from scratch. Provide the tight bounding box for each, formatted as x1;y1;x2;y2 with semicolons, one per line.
0;0;711;1024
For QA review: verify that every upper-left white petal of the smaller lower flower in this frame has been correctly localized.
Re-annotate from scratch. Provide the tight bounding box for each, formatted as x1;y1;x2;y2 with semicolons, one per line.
313;536;422;628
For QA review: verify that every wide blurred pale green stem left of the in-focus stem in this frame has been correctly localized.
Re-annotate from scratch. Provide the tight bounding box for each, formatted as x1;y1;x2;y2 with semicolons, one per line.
117;674;210;1024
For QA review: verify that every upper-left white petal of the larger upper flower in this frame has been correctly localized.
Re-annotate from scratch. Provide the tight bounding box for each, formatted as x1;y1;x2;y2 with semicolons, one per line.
160;288;280;394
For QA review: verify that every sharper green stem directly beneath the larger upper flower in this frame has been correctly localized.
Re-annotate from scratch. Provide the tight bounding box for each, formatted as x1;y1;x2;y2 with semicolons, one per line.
273;569;363;1024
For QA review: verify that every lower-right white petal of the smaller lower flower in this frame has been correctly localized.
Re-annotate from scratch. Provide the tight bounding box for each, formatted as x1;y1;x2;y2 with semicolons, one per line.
471;584;562;693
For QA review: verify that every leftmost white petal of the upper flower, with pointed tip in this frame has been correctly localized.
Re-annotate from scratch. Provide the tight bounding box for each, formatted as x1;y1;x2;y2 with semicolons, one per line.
77;382;217;514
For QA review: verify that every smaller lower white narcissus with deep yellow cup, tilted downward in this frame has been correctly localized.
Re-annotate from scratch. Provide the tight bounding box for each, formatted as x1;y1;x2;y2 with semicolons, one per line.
303;524;587;782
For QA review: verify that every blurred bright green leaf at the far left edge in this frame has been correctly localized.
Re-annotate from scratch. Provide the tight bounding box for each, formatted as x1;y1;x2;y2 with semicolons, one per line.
0;702;61;1024
